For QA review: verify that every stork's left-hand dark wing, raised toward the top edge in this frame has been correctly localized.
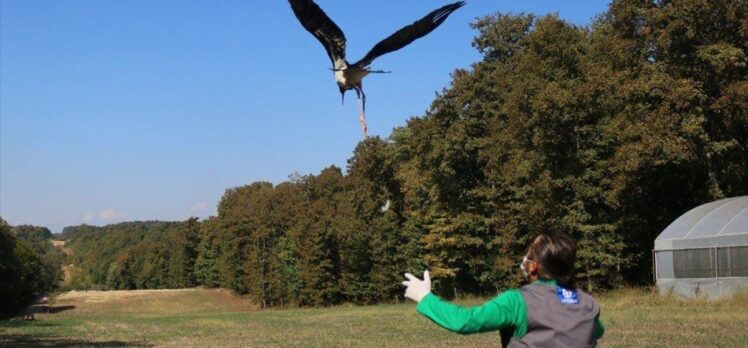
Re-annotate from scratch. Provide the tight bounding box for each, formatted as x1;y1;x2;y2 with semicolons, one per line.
288;0;345;69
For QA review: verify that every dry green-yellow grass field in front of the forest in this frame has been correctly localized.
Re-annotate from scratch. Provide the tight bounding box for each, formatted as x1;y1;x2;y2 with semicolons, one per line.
0;289;748;347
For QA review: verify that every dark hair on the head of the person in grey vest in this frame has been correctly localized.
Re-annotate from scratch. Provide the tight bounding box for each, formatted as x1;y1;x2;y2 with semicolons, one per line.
530;232;577;288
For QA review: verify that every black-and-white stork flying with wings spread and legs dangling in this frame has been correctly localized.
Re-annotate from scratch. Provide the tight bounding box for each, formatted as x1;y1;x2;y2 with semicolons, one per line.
288;0;465;137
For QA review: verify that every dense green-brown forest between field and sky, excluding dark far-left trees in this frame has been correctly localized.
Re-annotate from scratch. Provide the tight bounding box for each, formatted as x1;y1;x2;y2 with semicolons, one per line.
2;0;748;306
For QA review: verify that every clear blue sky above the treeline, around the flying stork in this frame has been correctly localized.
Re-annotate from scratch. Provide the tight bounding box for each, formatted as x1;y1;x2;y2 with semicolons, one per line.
0;0;608;232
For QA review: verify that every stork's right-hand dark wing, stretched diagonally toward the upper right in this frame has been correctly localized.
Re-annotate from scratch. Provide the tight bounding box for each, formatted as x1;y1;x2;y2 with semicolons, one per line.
353;1;465;68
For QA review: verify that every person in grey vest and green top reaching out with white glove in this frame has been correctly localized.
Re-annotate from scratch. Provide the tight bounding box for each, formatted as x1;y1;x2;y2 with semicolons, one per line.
403;233;605;347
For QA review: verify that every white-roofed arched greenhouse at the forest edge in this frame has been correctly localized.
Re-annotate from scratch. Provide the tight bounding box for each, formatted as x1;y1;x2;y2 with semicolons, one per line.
653;196;748;299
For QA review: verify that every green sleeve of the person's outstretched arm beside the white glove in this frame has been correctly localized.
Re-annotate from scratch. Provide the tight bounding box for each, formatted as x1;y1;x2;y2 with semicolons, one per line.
416;290;527;334
